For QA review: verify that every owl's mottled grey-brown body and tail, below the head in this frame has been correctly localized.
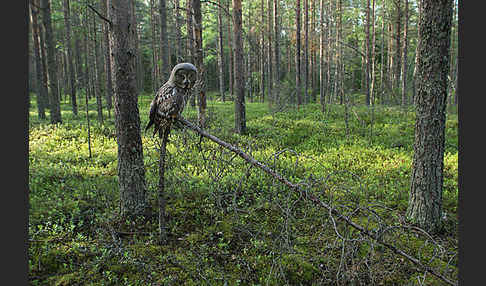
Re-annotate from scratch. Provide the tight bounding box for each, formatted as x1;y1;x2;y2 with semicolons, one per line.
145;83;188;135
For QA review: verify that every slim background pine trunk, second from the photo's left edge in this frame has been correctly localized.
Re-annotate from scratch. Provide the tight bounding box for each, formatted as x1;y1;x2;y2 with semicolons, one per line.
41;0;62;124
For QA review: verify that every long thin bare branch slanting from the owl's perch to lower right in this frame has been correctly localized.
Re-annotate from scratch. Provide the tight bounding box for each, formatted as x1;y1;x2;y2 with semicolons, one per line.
176;117;458;285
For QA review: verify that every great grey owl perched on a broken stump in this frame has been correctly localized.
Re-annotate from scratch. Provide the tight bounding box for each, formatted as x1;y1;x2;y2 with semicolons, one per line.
145;63;197;135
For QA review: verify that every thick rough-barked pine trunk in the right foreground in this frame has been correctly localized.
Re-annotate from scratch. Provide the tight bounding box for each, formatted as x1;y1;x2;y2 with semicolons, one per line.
407;0;452;232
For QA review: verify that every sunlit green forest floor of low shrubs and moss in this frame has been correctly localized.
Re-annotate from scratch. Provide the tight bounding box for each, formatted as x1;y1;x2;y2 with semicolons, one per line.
28;94;458;285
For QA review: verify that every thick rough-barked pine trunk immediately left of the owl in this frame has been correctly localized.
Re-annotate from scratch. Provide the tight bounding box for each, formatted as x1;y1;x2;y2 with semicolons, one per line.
108;0;147;216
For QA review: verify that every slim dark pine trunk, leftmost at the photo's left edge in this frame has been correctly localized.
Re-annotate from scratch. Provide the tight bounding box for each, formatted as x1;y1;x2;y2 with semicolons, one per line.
30;1;48;119
